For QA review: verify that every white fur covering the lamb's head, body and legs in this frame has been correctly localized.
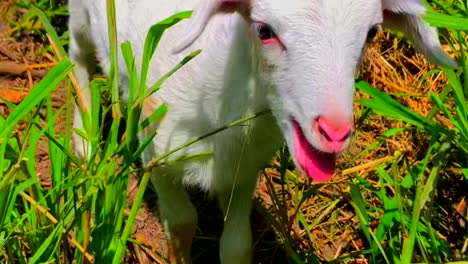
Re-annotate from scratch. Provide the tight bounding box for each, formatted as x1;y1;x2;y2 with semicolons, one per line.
70;0;453;263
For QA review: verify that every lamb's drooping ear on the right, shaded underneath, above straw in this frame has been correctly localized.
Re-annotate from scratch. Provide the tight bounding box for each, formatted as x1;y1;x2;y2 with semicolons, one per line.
382;0;457;69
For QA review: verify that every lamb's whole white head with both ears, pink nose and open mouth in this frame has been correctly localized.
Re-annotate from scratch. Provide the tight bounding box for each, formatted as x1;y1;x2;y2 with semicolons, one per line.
176;0;456;181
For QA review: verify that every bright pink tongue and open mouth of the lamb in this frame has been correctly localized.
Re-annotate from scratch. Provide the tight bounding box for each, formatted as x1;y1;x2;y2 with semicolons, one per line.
293;122;336;182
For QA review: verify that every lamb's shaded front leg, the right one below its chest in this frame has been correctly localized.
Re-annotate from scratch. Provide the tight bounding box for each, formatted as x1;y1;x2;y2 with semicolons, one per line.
218;175;257;264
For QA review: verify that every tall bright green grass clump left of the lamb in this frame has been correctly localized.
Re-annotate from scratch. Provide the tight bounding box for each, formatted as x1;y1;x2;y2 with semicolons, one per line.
0;1;199;263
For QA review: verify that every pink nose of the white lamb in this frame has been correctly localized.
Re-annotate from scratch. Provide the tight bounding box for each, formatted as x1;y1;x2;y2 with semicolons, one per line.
315;116;353;152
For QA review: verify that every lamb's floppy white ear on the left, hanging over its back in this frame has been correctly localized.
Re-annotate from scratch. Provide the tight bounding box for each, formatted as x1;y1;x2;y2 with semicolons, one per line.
173;0;250;53
